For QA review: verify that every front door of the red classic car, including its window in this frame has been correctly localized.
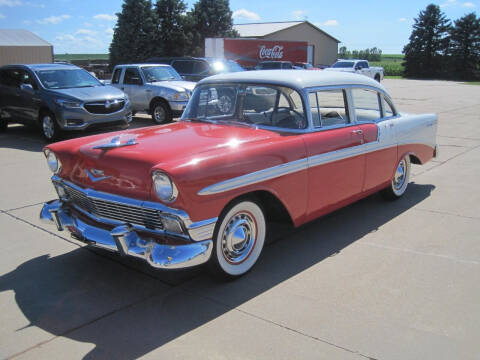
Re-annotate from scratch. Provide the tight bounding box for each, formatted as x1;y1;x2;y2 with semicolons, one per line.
303;89;365;219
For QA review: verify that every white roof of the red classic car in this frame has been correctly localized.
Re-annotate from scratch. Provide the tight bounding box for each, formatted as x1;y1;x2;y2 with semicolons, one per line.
199;70;387;93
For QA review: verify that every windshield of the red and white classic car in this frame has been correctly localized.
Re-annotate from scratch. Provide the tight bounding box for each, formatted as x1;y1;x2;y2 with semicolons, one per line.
182;84;307;129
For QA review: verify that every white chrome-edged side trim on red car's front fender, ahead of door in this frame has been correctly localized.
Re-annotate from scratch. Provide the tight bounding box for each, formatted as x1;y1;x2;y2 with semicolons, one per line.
198;158;308;195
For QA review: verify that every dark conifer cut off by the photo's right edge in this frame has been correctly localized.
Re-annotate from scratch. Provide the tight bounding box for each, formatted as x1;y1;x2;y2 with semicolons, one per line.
450;13;480;79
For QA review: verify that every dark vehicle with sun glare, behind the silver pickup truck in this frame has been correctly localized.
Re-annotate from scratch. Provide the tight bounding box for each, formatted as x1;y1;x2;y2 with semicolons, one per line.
147;57;245;82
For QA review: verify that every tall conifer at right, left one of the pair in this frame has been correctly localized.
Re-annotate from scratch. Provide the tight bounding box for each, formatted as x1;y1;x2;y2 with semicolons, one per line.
403;4;450;78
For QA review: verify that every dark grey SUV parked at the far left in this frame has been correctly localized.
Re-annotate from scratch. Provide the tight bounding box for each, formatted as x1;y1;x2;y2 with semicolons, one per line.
0;64;132;141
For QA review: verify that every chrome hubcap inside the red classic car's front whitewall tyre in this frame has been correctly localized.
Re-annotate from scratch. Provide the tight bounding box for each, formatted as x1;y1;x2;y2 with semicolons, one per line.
222;212;257;264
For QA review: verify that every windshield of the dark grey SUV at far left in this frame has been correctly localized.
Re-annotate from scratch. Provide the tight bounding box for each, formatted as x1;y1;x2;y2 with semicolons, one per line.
36;69;102;89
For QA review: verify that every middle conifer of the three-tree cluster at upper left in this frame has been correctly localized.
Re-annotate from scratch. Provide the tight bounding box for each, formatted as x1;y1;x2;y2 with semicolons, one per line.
154;0;192;56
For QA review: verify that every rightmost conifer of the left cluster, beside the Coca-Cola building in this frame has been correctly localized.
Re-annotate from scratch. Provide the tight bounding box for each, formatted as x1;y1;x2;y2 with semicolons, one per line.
187;0;238;56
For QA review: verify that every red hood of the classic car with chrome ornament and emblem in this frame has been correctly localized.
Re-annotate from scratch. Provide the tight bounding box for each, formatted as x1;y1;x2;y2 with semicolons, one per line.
53;121;278;200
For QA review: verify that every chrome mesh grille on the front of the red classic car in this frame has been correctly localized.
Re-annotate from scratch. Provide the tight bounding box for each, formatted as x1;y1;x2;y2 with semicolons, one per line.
64;185;163;229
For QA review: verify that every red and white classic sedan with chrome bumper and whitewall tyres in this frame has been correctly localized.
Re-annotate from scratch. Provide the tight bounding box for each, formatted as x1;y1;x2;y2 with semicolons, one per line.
40;70;437;277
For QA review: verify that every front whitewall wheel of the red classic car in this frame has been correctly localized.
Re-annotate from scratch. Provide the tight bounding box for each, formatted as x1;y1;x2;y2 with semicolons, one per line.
209;200;267;278
